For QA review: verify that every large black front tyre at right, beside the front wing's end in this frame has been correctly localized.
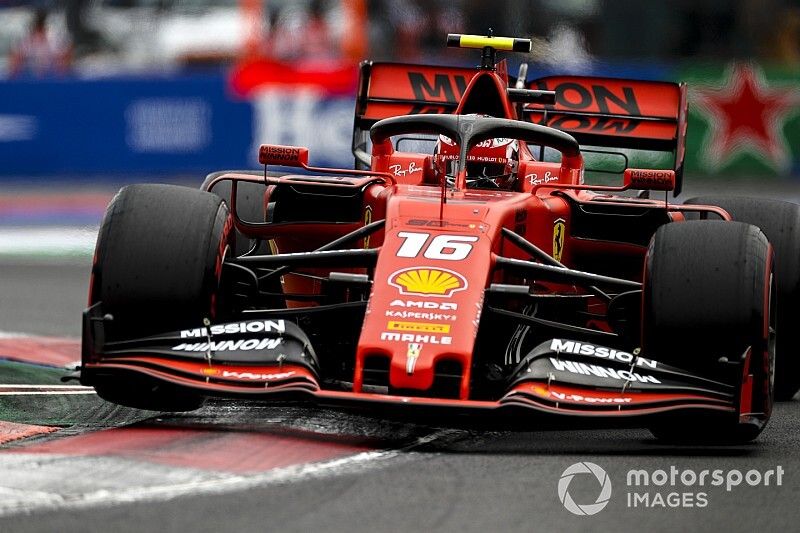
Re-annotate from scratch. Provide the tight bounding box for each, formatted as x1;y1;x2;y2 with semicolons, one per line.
642;221;775;443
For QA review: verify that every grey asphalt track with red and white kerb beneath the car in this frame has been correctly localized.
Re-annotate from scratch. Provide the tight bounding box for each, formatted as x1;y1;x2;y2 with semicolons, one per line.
0;182;800;532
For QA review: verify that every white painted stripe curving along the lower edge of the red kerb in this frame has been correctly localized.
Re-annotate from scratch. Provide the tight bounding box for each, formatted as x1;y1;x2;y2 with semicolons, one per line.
0;429;455;516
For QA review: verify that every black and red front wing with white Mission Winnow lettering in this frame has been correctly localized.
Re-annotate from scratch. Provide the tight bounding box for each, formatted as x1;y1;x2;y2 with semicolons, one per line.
80;308;751;419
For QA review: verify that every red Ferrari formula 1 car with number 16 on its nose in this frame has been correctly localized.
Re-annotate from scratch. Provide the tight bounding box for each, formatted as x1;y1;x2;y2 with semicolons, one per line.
80;35;800;441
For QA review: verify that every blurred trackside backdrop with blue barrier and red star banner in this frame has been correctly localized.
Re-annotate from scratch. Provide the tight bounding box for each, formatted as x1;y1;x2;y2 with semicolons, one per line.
0;0;800;257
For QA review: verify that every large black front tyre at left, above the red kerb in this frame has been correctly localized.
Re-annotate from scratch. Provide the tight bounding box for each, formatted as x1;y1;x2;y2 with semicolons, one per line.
91;185;233;411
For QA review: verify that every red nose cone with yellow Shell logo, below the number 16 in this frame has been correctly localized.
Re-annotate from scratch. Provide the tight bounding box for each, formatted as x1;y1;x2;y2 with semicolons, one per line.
354;245;491;398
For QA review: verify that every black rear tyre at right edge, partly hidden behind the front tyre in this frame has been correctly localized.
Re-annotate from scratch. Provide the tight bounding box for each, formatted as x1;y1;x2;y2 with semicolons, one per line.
686;196;800;400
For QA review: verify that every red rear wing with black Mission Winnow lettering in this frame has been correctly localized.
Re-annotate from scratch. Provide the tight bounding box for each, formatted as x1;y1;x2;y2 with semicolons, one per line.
352;61;687;195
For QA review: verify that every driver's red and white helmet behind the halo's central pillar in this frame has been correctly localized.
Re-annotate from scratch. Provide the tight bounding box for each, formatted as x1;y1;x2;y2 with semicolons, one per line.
433;135;519;190
